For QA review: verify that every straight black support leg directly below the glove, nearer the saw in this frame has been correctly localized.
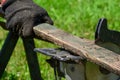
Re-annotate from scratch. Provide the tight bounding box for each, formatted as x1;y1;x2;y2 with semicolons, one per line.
23;38;43;80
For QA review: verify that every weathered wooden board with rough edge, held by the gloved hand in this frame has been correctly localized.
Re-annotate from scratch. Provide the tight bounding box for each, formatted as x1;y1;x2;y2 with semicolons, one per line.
34;23;120;75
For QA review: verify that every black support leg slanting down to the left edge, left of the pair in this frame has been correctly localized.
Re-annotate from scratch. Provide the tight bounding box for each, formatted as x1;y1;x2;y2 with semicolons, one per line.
0;32;18;78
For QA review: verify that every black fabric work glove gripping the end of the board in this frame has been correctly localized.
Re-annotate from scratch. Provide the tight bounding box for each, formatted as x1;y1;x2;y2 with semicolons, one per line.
2;0;53;37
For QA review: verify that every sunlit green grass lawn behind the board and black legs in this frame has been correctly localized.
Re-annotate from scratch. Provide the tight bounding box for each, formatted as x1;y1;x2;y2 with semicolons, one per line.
0;0;120;80
